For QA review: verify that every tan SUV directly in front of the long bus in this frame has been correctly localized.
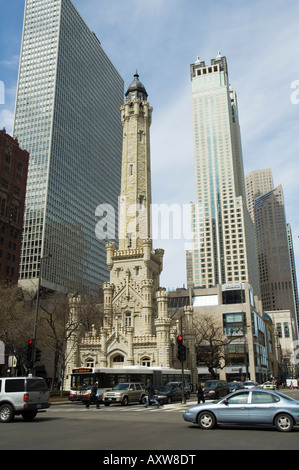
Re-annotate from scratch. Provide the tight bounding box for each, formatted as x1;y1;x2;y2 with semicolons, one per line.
103;382;146;406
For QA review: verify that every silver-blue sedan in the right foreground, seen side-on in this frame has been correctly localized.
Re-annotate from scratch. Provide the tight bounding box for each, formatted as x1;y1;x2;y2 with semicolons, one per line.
183;389;299;432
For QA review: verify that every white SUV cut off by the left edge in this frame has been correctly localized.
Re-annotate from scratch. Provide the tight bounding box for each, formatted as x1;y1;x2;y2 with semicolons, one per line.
0;377;50;423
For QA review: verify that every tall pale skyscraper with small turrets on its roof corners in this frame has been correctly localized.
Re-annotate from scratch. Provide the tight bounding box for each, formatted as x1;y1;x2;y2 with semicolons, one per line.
191;53;259;294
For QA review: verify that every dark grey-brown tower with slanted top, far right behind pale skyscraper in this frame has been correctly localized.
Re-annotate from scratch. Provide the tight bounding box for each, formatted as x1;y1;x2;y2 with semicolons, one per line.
254;185;297;336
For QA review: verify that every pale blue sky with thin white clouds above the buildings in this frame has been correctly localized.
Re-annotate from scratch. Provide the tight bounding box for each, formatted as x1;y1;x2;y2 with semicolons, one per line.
0;0;299;289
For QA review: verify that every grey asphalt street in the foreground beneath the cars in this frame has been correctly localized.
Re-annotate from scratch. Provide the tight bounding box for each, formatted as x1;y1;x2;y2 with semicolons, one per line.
0;390;299;454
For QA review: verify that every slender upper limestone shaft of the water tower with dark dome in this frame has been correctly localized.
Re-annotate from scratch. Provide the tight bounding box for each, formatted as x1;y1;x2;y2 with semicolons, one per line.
119;71;152;249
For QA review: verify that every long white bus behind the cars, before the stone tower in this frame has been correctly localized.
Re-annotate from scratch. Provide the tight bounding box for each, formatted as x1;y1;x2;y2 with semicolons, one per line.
69;366;191;401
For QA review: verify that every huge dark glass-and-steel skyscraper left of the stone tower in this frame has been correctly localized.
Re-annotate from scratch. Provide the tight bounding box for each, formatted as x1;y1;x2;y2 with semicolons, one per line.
13;0;124;291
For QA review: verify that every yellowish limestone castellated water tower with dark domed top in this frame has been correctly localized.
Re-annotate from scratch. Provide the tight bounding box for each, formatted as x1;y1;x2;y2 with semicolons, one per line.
101;73;170;367
